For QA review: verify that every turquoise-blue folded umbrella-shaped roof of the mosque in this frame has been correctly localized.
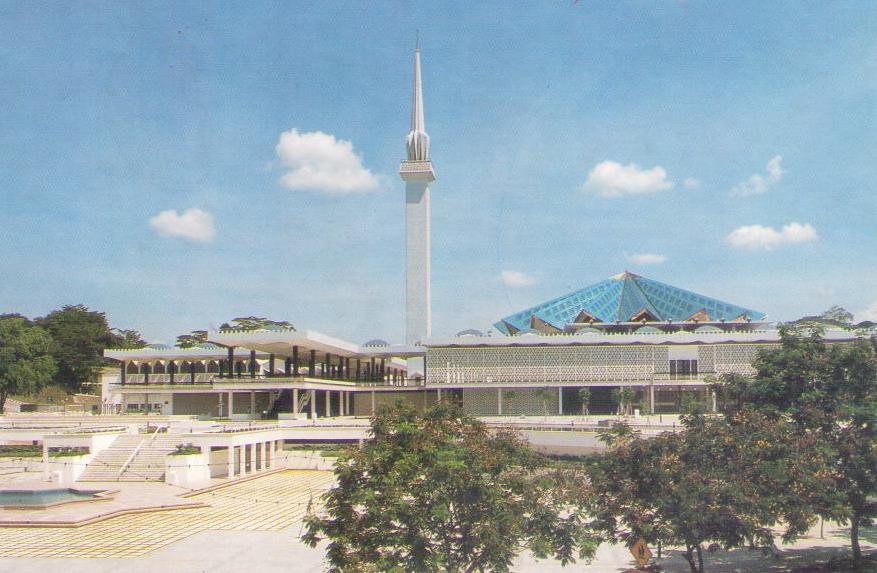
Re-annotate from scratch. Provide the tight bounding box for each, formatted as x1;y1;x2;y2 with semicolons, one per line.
494;272;766;334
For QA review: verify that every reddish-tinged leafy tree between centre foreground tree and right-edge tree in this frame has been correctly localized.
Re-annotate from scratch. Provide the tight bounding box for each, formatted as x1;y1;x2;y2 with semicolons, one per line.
583;414;808;573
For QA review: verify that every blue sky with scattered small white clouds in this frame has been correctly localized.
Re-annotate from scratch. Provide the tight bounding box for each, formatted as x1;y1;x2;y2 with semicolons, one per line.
0;0;877;341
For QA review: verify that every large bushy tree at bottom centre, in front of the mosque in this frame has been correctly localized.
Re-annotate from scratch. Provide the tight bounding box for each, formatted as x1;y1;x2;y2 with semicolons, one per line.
303;405;595;573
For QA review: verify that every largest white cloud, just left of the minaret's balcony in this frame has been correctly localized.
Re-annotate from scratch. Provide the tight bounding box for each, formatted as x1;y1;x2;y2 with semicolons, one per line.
275;129;378;195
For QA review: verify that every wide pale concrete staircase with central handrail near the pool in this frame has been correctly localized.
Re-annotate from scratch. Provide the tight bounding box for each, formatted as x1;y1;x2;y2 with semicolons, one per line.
78;434;181;481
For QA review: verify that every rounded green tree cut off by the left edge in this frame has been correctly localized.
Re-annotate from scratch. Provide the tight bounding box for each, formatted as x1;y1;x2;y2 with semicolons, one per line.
0;315;55;412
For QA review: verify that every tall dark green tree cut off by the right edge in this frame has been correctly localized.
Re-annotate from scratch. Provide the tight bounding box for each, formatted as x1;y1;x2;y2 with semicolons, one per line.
720;329;877;568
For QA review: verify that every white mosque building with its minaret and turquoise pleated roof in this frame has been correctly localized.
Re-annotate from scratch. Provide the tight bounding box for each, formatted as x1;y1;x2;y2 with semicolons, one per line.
102;45;856;419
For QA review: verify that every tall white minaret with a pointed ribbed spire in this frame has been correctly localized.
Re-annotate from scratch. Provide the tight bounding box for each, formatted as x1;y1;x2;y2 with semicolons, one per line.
399;39;435;344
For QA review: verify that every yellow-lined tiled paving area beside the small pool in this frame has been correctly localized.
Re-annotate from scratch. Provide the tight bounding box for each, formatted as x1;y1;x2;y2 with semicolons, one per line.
0;470;334;557
